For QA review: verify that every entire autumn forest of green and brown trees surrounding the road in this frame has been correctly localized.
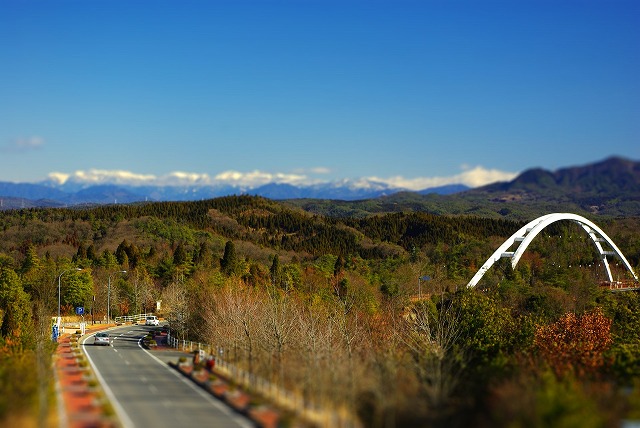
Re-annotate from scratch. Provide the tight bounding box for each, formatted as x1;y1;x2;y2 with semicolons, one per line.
0;196;640;427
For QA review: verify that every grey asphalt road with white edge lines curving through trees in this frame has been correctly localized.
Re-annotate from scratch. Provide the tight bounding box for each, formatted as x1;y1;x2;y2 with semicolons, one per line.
82;325;255;428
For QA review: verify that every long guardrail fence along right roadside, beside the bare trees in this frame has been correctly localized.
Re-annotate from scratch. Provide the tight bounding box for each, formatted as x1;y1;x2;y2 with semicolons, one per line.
167;331;358;427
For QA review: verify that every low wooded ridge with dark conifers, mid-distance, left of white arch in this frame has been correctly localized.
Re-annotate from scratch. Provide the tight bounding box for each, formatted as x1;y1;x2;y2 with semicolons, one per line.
0;196;520;258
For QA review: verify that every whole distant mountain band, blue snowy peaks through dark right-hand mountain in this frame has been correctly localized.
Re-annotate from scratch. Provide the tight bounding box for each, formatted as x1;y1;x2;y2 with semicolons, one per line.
0;157;640;218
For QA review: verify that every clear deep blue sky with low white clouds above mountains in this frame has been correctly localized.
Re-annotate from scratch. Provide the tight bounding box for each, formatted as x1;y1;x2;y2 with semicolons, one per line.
0;0;640;188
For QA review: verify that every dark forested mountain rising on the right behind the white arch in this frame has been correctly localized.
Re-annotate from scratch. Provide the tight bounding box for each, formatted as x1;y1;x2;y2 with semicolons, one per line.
288;157;640;220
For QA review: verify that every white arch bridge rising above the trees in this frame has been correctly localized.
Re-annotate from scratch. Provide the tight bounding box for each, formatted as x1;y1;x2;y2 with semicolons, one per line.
467;213;640;289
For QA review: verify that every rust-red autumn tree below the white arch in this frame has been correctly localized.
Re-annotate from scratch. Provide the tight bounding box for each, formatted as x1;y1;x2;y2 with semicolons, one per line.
534;308;612;377
